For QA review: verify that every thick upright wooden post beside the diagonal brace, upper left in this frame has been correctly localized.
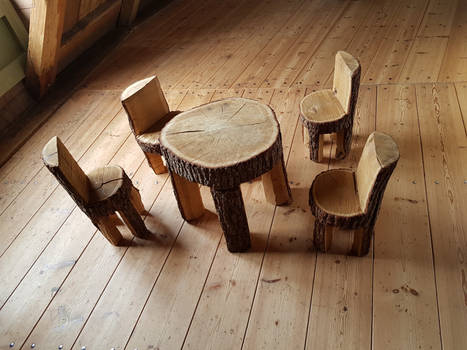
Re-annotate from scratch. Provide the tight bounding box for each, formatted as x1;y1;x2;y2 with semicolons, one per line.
26;0;66;98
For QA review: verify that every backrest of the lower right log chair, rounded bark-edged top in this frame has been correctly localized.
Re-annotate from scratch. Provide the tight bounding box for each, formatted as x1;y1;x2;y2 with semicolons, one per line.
355;132;399;213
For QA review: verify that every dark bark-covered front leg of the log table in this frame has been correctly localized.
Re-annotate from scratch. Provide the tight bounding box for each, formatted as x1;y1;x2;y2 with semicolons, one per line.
211;186;251;253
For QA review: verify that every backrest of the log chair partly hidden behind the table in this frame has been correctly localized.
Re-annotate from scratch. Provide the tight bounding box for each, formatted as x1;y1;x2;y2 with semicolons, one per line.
121;76;169;135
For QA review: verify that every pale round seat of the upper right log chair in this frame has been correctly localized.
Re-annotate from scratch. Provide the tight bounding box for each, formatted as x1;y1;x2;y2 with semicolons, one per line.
300;89;345;123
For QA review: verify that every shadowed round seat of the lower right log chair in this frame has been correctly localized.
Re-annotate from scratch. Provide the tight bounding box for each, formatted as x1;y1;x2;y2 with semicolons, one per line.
312;169;362;217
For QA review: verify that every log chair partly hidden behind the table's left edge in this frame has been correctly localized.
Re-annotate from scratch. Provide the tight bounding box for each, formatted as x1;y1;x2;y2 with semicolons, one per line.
121;76;179;174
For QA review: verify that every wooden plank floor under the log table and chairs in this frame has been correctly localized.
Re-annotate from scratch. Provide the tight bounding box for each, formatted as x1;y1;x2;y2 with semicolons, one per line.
0;0;467;350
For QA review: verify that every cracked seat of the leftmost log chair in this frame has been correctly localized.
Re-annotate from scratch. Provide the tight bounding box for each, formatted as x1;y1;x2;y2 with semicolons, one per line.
87;165;124;202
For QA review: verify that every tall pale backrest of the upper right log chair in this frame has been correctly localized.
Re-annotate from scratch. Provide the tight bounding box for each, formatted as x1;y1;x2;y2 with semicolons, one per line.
333;51;360;114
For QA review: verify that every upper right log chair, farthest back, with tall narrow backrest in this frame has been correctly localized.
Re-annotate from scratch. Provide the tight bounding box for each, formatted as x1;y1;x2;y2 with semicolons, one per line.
300;51;360;162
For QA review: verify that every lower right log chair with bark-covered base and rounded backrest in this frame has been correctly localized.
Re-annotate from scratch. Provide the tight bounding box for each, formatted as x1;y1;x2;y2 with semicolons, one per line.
310;132;399;256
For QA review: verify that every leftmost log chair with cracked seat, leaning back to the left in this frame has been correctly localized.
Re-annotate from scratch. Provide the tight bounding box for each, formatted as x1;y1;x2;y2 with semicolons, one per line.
42;136;149;245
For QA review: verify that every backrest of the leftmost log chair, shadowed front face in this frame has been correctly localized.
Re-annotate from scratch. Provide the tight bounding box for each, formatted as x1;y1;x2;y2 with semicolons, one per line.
42;136;90;203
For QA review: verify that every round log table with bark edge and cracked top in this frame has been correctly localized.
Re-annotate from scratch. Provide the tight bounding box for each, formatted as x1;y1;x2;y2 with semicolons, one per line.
160;98;292;252
